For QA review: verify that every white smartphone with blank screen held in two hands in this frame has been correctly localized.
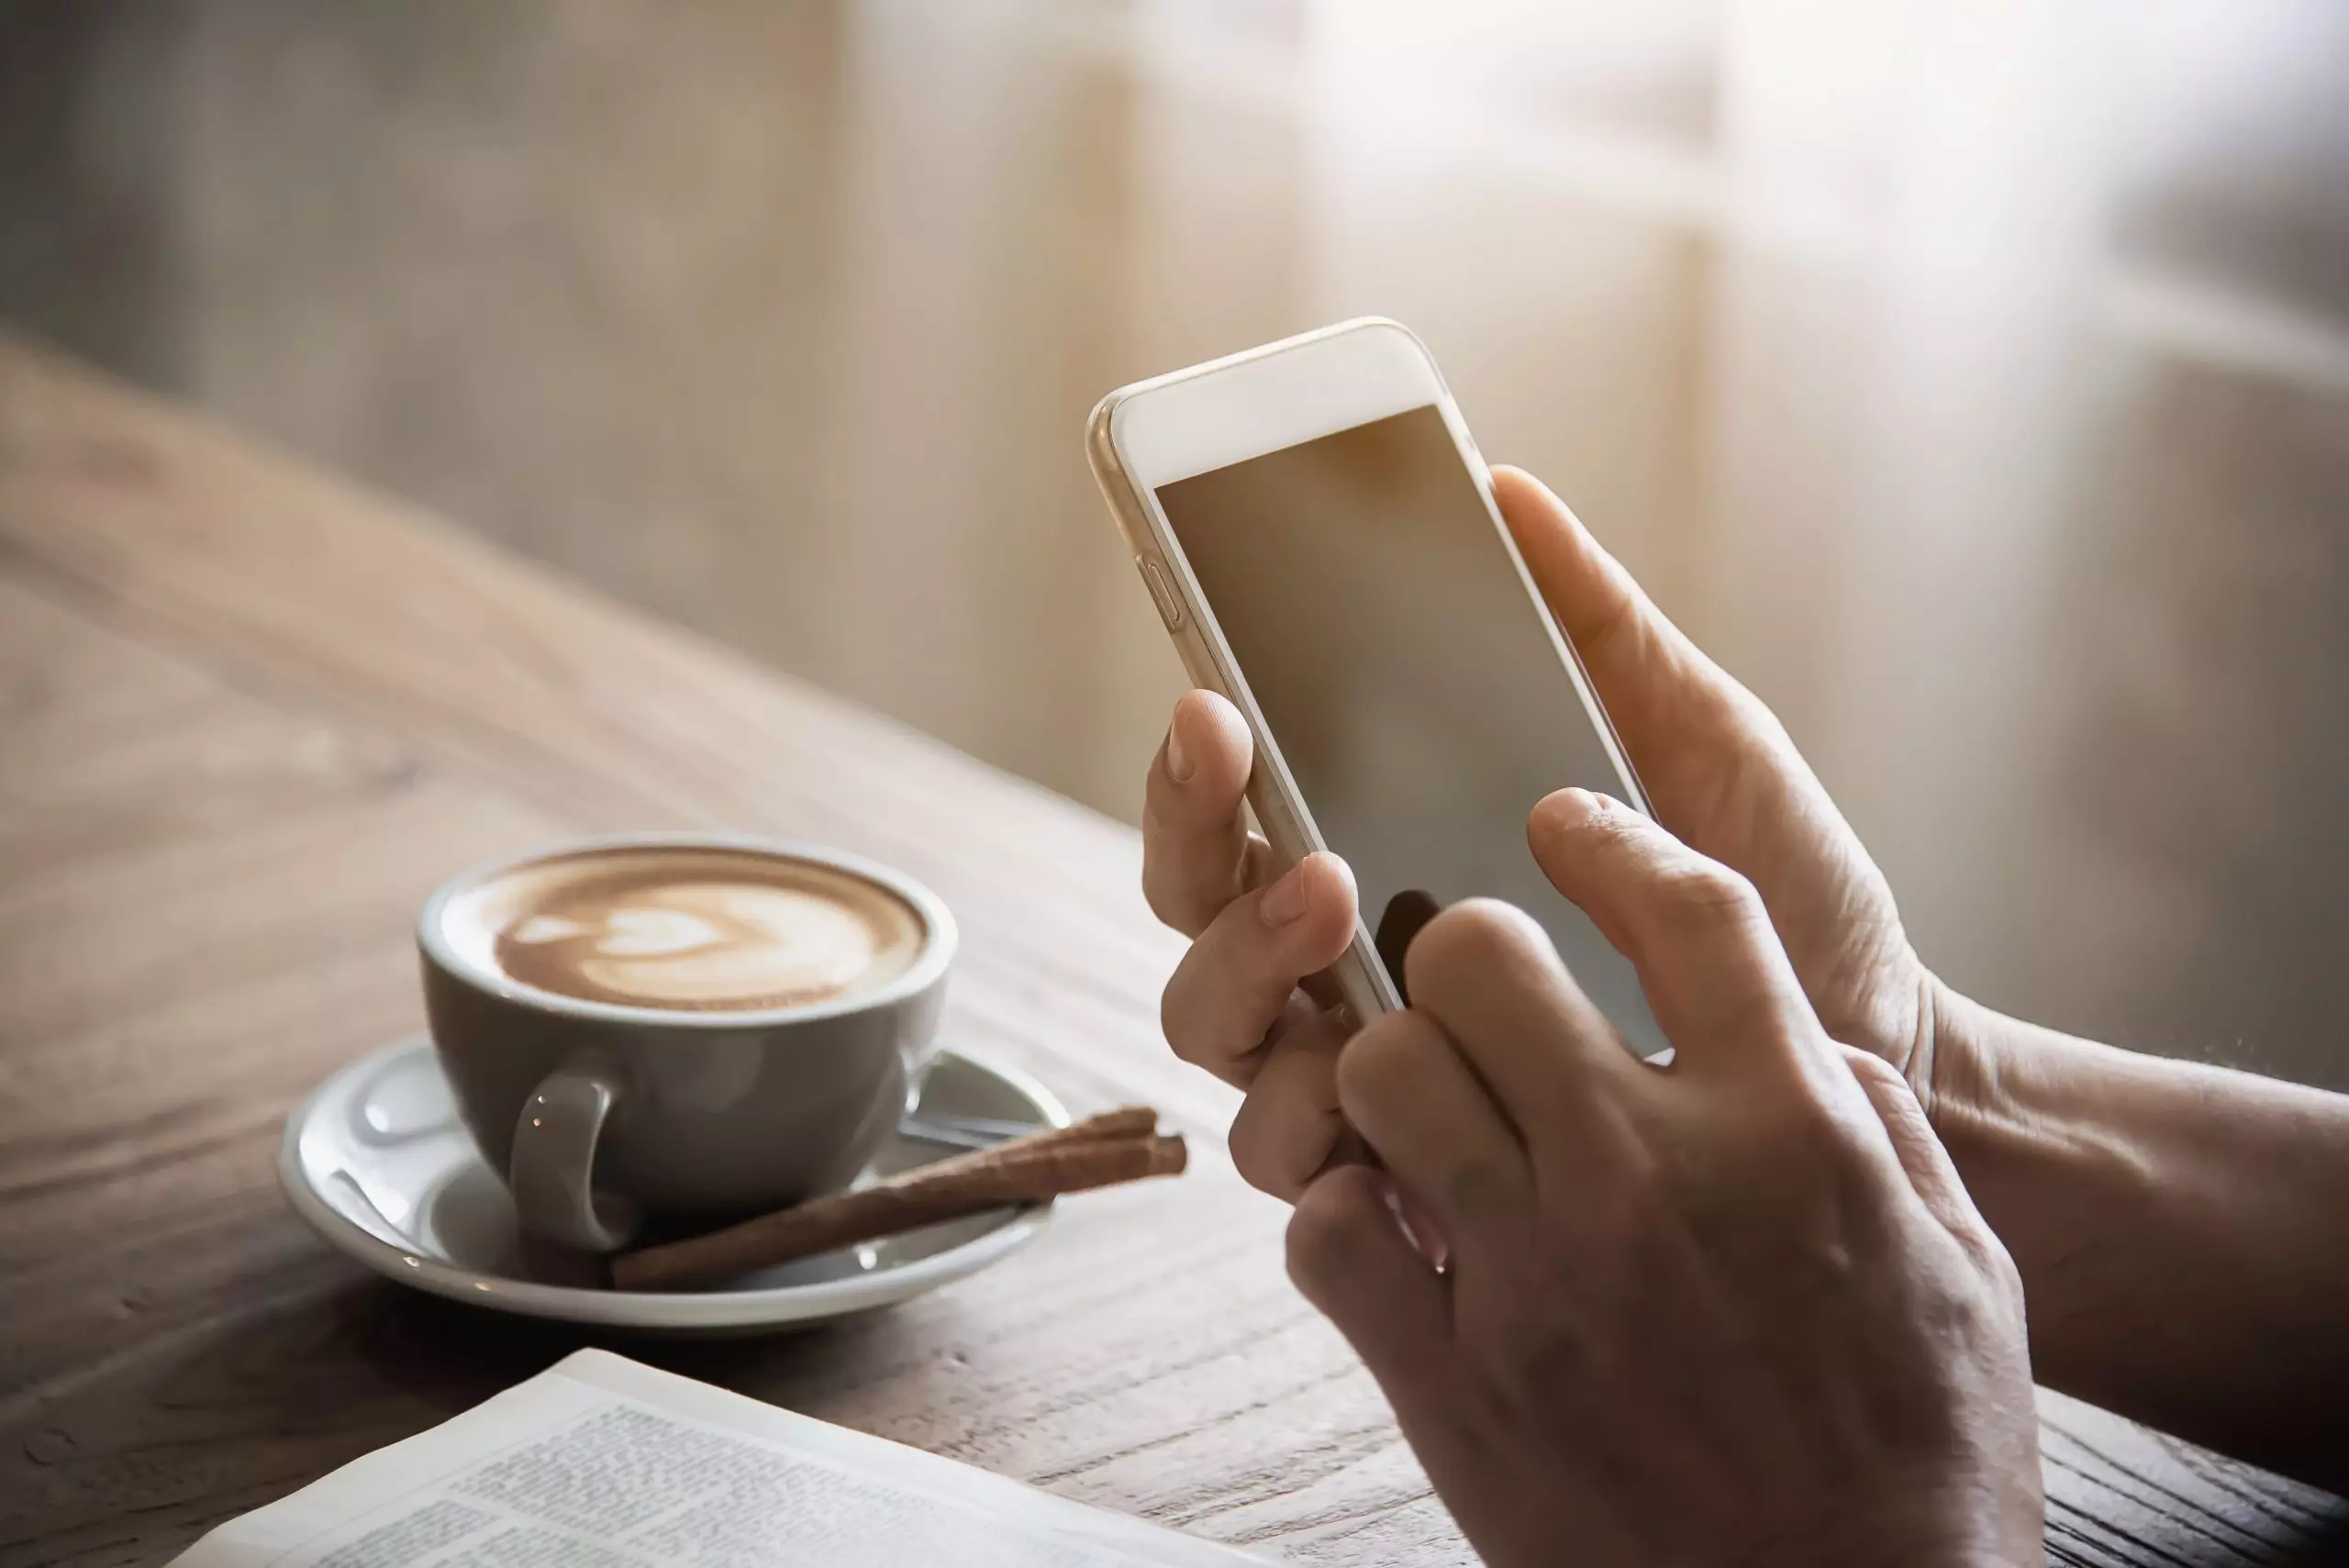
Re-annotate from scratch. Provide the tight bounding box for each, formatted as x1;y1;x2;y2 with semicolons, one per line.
1087;319;1665;1056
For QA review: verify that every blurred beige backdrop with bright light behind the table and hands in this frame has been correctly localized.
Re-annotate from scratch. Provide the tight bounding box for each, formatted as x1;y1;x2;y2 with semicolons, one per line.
0;0;2349;1087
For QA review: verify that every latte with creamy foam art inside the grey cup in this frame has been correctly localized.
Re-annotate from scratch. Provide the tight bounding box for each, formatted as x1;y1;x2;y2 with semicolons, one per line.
441;845;928;1012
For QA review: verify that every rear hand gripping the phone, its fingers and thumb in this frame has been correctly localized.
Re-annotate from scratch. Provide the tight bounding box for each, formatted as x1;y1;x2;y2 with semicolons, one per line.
1141;467;1941;1197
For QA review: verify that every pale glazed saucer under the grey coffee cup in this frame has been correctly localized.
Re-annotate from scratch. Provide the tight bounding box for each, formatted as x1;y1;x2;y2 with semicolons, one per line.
277;1035;1069;1333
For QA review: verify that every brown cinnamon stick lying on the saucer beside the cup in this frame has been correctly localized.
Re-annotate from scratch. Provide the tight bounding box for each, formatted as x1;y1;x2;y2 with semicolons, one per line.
611;1106;1186;1291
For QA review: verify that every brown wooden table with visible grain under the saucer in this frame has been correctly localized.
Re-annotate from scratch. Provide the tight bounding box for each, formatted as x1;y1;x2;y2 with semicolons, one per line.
0;338;2349;1568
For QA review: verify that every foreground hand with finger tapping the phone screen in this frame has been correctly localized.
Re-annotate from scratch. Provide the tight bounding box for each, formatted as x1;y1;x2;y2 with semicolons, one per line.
1289;791;2043;1568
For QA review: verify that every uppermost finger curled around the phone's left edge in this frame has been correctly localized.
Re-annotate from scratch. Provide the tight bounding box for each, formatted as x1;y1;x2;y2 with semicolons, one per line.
1141;690;1259;937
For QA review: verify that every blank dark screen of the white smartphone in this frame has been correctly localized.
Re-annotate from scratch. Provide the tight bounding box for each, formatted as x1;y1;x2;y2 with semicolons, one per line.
1158;404;1665;1056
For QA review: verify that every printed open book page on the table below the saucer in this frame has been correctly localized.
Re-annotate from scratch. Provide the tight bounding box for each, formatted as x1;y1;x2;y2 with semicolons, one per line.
176;1350;1259;1568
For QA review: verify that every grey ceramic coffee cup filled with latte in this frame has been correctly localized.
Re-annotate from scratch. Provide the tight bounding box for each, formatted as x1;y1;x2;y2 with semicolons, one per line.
416;833;956;1251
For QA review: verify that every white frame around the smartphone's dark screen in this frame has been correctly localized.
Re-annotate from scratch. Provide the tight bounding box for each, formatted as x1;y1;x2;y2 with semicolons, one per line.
1087;317;1649;1018
